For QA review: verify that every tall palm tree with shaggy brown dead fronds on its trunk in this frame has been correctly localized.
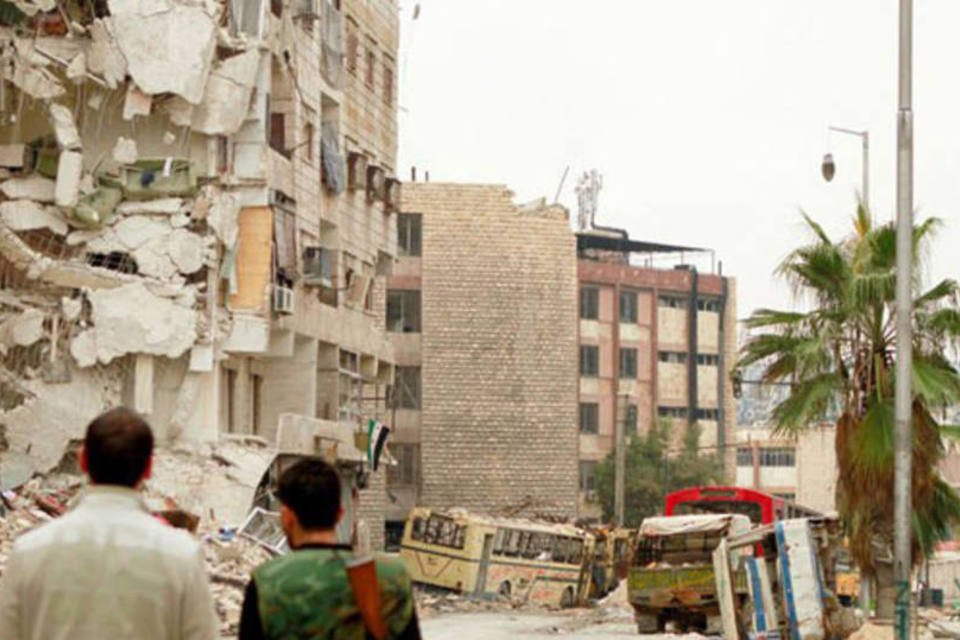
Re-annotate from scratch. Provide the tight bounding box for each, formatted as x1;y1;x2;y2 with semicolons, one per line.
739;206;960;617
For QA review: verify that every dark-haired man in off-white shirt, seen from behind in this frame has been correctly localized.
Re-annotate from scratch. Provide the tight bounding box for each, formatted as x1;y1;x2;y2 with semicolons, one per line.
0;409;218;640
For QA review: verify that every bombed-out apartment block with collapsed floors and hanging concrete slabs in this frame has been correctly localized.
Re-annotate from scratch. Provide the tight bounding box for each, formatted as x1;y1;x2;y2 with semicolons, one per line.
0;0;399;546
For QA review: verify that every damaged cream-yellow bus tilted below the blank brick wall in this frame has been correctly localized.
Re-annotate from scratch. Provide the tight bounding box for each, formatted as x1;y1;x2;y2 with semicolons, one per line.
400;507;594;607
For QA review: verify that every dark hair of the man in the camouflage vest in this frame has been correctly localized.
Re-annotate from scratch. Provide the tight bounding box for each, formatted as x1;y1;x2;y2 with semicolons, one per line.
277;458;340;529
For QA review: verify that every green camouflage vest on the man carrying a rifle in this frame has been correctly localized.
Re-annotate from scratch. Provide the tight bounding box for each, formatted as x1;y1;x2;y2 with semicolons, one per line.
246;546;419;640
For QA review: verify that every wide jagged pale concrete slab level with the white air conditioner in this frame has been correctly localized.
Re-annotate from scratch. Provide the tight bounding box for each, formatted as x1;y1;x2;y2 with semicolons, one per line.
70;282;197;367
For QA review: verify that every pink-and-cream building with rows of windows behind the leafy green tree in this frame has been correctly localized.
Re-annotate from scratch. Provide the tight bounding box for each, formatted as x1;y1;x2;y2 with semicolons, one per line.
577;228;736;516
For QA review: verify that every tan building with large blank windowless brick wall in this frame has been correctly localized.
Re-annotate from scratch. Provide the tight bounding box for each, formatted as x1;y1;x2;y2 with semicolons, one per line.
387;183;577;544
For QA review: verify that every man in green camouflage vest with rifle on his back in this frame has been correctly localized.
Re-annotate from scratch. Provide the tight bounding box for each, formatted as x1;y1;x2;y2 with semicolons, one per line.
240;459;420;640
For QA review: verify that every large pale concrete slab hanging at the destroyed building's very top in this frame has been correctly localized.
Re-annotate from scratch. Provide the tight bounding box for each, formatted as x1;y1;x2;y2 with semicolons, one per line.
108;0;217;104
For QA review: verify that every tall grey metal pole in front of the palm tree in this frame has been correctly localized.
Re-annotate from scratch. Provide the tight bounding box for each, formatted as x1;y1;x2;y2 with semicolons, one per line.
893;0;913;640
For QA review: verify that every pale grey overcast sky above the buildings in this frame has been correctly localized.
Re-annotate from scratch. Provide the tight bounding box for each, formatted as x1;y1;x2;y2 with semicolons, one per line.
398;0;960;317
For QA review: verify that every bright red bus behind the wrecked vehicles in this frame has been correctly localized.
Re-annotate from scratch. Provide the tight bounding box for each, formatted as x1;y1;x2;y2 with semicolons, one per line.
663;487;823;524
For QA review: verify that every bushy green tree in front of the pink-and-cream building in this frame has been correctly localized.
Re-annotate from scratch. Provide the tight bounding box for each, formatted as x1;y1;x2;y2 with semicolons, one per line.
597;421;721;527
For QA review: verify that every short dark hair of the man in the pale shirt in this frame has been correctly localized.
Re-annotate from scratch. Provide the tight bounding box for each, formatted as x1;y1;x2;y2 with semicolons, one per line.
83;407;153;487
